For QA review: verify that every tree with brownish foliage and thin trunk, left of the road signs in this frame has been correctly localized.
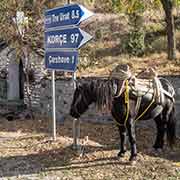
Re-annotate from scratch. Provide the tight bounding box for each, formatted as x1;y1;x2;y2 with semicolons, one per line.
0;0;47;115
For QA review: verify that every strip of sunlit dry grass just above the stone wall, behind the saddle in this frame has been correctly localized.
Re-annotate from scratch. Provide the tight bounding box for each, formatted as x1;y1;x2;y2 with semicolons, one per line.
78;53;180;76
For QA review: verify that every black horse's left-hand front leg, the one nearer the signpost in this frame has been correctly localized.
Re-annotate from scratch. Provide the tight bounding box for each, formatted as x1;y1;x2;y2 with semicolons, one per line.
118;125;126;157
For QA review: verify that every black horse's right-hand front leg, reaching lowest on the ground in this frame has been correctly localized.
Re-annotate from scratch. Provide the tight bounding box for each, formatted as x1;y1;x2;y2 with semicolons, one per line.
127;118;137;161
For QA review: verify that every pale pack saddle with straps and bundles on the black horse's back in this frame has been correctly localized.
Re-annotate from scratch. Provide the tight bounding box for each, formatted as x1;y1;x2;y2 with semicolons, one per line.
110;64;174;120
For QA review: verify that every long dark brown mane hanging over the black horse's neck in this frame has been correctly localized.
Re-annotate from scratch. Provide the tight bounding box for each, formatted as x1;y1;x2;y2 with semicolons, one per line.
79;79;113;111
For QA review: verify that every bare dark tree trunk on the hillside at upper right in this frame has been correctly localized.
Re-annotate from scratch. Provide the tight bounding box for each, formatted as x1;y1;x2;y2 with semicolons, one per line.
161;0;176;60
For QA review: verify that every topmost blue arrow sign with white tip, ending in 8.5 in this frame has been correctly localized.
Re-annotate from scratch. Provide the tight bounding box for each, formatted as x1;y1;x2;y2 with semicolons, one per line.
45;4;93;29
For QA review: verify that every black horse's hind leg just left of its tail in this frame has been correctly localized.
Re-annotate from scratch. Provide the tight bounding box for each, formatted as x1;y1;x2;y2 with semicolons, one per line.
153;113;166;150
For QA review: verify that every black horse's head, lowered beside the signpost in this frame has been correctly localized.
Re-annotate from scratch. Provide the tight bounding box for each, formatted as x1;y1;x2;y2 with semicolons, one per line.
70;83;95;118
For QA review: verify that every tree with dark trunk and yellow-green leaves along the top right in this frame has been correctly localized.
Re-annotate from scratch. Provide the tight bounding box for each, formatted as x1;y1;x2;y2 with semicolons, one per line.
112;0;180;59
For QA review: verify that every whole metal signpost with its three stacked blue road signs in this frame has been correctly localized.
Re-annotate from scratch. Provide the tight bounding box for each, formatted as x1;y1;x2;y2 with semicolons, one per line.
44;0;93;141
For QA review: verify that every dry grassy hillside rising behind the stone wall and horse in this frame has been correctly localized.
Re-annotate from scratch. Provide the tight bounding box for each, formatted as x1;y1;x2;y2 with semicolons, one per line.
74;12;180;76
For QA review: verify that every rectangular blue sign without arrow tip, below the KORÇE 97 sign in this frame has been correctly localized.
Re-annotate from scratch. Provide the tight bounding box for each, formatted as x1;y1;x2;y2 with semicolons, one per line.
45;51;78;72
